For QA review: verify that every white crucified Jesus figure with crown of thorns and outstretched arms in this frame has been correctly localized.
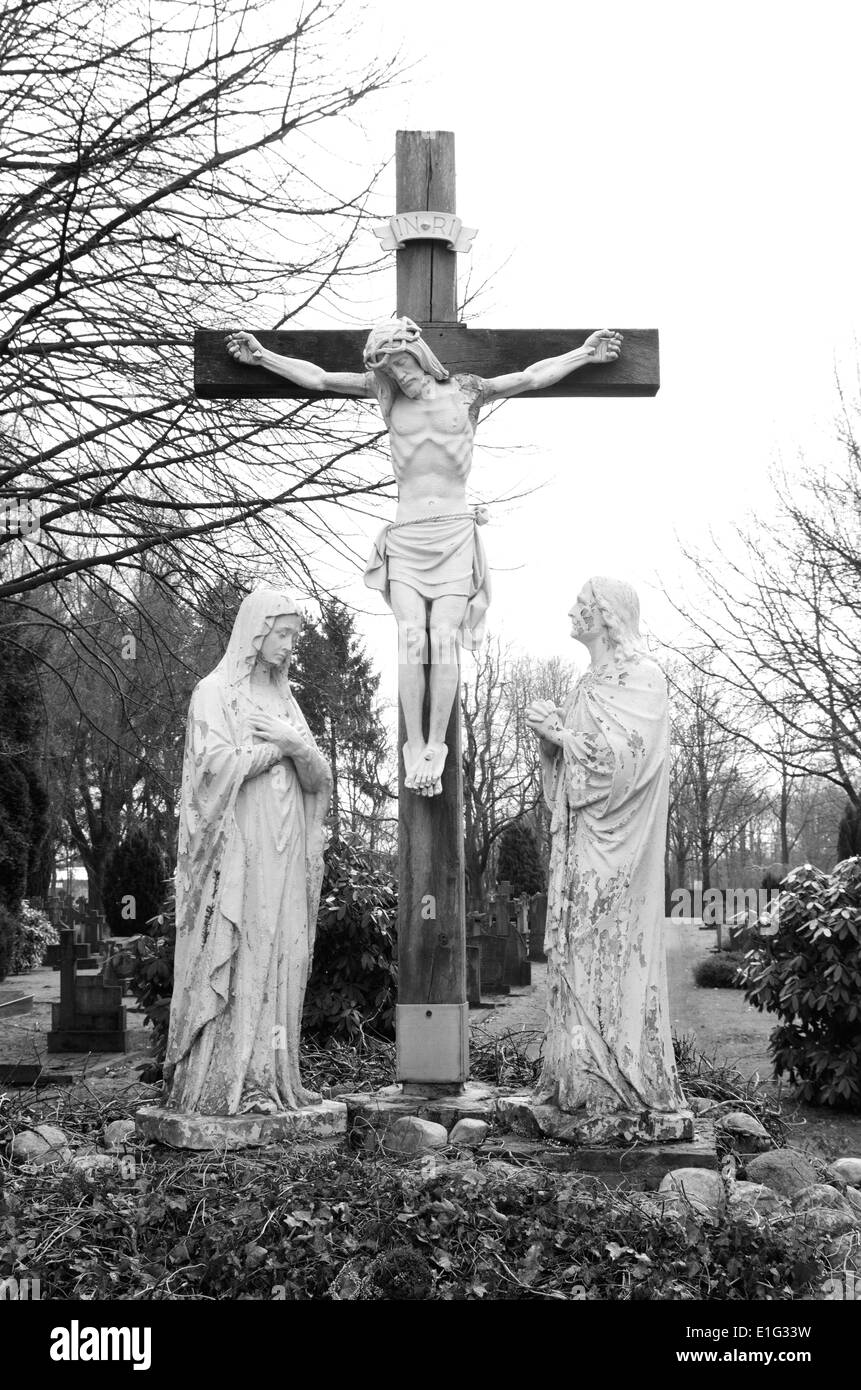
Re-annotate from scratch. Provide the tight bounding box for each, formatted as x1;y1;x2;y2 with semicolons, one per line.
227;318;622;796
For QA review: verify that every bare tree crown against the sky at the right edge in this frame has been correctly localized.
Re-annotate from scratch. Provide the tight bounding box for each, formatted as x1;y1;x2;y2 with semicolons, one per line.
670;398;861;811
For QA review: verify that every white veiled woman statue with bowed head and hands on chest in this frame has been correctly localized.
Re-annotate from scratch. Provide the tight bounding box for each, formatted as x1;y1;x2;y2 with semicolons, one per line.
164;589;331;1115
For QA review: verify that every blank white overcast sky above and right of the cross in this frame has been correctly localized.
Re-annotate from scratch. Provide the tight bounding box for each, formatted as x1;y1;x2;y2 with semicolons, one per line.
289;0;861;698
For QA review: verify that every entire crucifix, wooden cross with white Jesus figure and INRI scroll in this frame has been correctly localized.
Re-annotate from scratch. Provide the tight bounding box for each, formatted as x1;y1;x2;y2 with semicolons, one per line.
195;131;659;1090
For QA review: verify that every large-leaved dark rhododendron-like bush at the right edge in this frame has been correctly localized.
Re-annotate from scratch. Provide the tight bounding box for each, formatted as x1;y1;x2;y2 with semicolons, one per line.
743;858;861;1109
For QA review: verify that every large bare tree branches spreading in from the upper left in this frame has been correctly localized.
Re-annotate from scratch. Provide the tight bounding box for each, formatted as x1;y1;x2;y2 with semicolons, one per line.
0;0;396;625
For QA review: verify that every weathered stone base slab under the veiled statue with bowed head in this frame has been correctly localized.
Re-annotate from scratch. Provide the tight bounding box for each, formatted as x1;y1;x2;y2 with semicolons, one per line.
135;1101;346;1150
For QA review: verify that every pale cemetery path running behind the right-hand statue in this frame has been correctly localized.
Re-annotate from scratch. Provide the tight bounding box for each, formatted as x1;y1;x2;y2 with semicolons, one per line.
470;917;861;1159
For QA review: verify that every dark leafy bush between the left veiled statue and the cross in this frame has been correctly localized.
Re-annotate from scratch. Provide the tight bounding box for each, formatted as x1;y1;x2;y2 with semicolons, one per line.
302;841;398;1041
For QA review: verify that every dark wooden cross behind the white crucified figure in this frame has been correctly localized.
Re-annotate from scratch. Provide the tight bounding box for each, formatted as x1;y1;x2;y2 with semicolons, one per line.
195;131;659;1090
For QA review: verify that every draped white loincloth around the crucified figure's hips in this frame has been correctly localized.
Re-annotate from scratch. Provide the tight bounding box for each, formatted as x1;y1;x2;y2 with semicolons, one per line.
364;512;491;651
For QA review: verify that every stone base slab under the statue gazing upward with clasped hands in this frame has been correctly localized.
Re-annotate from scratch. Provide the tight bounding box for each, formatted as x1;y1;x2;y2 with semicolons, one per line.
497;1094;694;1147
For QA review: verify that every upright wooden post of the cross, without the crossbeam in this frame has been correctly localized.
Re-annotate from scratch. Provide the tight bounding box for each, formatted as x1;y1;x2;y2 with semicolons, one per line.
395;131;469;1088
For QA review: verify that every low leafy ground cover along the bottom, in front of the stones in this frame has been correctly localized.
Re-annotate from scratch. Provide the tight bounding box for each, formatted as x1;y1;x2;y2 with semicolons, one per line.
0;1125;825;1304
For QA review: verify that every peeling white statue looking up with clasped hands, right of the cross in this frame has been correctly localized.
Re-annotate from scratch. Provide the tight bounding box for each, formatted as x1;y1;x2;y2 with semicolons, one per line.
527;578;691;1140
